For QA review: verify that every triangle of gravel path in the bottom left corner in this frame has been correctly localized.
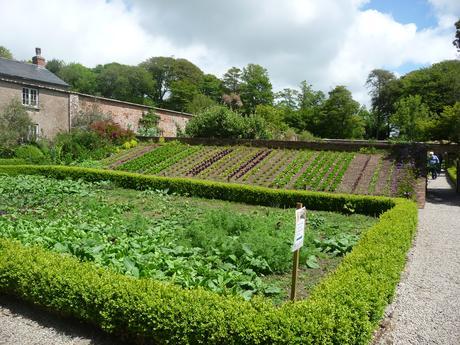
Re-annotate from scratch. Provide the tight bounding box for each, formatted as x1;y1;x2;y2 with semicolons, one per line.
0;295;128;345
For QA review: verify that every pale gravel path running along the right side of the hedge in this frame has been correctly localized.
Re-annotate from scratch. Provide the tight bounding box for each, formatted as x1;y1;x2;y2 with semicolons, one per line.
374;174;460;345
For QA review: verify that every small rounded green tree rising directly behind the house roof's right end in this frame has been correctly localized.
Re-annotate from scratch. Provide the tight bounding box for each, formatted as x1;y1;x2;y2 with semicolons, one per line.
58;63;97;95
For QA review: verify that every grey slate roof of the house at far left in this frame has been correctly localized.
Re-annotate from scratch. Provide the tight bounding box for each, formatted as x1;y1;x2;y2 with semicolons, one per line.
0;57;69;88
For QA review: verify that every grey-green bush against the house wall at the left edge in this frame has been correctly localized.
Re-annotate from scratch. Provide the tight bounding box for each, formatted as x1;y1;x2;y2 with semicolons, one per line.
0;99;32;150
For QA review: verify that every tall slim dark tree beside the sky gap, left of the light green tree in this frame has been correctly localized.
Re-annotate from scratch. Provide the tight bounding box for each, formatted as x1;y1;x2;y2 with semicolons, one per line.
366;69;396;139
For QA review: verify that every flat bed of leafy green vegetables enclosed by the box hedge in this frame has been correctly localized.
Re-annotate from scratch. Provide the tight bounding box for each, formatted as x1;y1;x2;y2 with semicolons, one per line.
0;176;376;302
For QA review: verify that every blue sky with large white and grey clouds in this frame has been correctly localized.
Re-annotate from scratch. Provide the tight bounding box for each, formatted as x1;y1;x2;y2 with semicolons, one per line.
0;0;460;104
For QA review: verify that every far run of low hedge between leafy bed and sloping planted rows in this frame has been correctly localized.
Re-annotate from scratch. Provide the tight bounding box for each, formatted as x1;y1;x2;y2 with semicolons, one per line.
0;165;394;216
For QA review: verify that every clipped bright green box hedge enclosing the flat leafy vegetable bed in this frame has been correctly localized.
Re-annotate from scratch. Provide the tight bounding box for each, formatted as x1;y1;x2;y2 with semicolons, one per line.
0;166;417;344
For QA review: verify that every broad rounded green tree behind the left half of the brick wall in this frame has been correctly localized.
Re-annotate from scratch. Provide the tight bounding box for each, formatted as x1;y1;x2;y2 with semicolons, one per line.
95;62;154;104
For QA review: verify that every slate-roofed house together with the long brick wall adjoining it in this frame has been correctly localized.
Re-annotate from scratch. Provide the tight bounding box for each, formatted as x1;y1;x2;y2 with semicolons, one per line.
0;48;192;139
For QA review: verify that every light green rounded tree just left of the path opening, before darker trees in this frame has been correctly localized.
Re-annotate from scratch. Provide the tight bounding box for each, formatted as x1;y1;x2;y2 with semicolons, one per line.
390;95;431;141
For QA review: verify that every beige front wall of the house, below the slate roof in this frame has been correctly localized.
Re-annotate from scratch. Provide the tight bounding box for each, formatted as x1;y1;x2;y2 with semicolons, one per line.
0;80;69;139
